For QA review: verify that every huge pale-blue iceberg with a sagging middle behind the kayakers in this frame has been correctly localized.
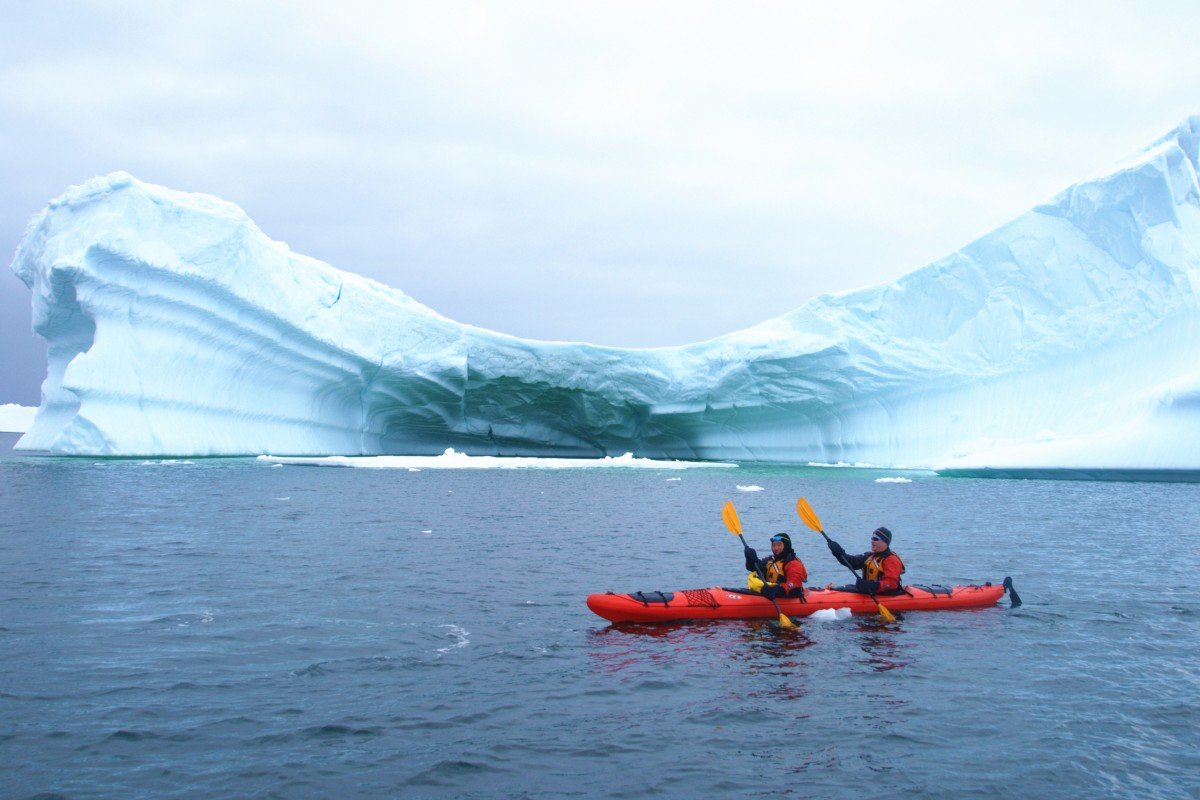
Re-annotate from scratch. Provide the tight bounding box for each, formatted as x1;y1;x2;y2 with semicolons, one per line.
12;116;1200;474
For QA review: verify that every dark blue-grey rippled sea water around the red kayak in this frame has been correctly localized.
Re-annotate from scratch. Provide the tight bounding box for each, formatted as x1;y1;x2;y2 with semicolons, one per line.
0;443;1200;800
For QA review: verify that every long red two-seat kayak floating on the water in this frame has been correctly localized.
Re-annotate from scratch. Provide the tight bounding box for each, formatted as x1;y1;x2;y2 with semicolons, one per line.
588;578;1019;622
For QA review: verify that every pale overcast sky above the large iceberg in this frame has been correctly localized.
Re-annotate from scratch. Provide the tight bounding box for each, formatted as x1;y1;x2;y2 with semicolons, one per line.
0;0;1200;404
